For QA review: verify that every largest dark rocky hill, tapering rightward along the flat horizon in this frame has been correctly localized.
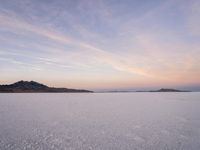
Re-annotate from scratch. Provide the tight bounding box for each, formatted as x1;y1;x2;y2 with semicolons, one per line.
0;81;93;93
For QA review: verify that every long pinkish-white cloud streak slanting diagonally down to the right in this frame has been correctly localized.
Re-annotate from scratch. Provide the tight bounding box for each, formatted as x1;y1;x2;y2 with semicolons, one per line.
0;11;153;76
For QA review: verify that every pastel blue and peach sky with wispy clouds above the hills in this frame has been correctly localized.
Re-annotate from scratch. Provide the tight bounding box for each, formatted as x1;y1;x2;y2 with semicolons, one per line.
0;0;200;90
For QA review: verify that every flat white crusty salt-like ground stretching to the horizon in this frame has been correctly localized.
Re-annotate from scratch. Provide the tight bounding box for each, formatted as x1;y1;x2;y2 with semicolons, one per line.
0;93;200;150
